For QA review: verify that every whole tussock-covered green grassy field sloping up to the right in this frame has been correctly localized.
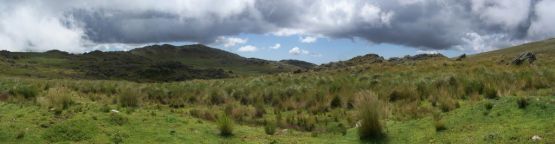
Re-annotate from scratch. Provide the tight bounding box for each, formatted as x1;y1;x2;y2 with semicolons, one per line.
0;40;555;143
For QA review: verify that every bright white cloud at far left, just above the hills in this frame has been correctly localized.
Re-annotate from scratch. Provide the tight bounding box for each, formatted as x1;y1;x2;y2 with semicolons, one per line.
0;5;87;53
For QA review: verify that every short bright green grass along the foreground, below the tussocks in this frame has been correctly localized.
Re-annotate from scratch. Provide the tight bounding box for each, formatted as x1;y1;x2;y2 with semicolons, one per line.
0;97;555;143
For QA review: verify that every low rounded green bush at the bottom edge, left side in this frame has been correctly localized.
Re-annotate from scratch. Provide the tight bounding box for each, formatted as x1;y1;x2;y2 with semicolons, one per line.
42;120;96;143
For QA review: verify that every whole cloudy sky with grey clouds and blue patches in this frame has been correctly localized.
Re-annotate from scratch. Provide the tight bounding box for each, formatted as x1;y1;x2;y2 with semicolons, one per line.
0;0;555;63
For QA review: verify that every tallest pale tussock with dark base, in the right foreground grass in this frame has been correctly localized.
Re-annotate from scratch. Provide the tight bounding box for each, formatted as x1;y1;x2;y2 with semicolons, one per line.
356;91;385;140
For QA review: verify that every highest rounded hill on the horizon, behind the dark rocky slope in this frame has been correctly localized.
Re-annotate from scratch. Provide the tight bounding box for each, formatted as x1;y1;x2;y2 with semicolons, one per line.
130;44;312;75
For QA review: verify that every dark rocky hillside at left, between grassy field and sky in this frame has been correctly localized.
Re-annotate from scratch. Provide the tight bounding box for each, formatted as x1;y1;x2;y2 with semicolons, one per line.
0;45;312;82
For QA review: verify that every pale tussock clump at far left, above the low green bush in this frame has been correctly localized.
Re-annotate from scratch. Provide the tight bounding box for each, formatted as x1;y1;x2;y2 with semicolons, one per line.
39;87;76;110
